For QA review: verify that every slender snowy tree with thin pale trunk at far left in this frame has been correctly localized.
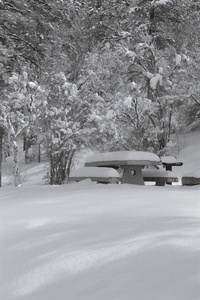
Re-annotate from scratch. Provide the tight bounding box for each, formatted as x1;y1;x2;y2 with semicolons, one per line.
0;70;42;186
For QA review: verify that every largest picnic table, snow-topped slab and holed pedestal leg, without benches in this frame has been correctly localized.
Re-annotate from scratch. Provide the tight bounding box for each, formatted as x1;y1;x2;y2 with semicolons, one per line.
85;151;162;185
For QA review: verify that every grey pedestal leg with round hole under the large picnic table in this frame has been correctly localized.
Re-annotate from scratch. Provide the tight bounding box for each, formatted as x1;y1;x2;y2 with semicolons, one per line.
122;166;144;185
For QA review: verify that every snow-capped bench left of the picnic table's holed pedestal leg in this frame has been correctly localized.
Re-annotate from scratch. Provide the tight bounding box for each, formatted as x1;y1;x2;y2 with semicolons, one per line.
69;167;121;183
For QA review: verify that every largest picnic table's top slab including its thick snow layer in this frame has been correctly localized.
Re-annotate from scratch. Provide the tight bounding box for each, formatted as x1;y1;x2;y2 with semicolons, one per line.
85;151;161;167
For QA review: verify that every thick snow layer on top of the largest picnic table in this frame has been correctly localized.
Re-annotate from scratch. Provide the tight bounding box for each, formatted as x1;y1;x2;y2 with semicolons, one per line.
86;151;160;163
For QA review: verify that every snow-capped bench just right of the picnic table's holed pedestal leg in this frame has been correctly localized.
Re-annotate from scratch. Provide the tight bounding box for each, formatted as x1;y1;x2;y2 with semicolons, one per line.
142;169;178;186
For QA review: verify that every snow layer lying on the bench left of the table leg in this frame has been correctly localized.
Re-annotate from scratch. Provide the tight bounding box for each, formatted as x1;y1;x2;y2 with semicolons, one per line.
69;167;120;177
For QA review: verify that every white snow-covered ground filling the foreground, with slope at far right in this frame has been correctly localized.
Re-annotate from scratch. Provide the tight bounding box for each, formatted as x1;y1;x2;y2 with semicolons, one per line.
0;129;200;300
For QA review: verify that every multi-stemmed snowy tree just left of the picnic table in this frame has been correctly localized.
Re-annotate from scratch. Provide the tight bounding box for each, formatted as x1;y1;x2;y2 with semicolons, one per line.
41;72;107;184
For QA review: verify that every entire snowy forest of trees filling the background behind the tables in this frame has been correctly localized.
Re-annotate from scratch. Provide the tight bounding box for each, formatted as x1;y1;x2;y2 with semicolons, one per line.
0;0;200;186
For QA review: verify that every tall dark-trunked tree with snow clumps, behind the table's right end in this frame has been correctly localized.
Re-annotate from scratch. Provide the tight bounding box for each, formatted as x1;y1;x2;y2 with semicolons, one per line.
113;0;199;153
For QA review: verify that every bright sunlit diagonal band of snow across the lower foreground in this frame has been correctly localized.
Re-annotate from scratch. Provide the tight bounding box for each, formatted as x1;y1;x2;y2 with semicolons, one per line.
13;231;200;296
